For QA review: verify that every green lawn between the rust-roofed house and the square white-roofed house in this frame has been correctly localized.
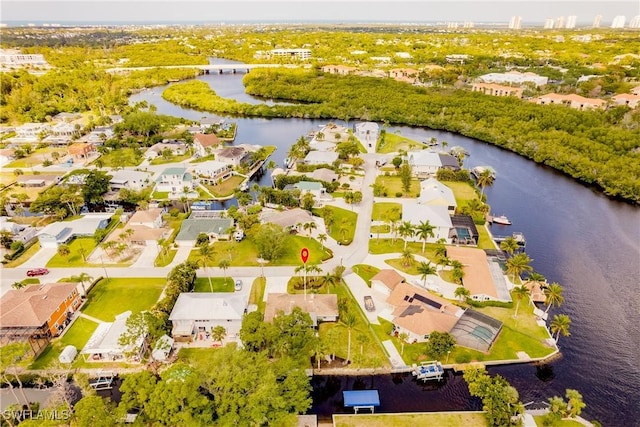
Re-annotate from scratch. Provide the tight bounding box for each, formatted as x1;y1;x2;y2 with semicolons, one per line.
82;277;166;322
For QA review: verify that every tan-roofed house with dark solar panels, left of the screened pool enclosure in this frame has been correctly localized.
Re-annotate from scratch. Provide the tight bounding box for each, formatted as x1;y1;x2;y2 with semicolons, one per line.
387;282;464;343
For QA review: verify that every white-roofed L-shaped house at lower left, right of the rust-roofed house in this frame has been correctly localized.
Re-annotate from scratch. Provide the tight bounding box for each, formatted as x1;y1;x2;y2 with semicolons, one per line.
80;311;145;362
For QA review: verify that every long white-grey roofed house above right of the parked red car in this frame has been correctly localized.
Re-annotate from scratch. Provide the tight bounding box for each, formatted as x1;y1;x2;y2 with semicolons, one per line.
37;213;111;248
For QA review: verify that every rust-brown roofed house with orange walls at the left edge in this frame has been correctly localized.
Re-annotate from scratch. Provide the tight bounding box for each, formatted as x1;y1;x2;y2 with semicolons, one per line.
0;283;80;356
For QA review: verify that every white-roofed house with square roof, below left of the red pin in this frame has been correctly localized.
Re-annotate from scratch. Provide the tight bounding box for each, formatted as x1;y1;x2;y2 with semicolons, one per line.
169;292;247;342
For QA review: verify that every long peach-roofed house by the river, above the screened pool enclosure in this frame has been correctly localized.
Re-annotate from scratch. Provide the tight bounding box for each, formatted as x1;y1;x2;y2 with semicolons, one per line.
447;246;511;302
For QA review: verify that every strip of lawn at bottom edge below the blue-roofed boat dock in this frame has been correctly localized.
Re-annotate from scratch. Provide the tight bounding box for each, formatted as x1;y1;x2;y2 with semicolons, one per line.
333;412;484;427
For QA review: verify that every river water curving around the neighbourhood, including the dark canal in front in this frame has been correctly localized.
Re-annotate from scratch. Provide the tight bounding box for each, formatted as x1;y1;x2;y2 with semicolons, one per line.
131;61;640;426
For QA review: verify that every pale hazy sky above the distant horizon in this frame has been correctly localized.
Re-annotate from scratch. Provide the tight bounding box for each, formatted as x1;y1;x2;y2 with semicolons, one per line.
0;0;640;26
